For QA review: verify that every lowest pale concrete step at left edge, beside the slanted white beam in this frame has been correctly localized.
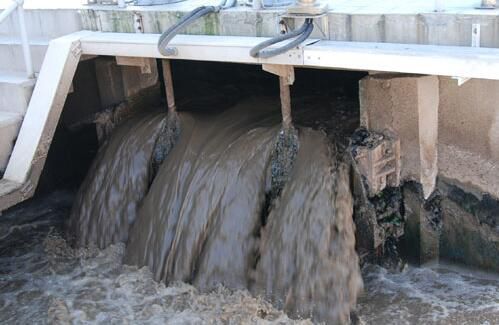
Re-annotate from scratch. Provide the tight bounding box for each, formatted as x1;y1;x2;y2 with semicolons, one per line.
0;111;23;173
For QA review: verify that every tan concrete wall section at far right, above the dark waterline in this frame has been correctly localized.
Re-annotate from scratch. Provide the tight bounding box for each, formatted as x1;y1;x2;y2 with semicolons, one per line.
438;78;499;198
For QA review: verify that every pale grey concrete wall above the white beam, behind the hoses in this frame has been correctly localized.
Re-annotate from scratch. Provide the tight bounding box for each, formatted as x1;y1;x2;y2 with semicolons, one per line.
81;8;499;48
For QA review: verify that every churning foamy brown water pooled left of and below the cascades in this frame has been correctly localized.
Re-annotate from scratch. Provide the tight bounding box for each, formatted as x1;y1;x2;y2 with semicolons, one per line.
0;193;310;324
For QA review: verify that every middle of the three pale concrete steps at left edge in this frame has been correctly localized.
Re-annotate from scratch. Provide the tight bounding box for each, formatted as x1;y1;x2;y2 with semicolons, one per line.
0;70;36;116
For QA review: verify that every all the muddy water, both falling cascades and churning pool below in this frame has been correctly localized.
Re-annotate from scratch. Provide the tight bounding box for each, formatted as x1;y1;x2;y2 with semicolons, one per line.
0;99;499;324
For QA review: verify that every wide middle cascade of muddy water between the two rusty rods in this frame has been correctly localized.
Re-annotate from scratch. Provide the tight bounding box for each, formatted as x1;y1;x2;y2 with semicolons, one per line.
126;98;279;288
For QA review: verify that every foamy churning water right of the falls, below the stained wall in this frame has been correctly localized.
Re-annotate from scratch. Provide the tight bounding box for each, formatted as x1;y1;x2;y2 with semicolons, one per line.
359;265;499;324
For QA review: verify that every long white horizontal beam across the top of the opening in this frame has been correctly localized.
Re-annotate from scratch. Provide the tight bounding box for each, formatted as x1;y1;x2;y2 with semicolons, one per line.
78;32;499;80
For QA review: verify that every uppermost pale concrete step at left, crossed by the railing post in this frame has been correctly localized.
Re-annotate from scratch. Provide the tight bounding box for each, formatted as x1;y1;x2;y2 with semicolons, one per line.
0;36;49;72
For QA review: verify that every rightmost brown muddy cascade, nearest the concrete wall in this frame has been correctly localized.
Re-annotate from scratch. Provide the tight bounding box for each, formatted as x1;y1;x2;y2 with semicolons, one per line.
254;129;362;324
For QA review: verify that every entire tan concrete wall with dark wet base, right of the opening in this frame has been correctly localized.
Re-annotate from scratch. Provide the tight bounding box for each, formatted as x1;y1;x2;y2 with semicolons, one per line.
360;74;499;271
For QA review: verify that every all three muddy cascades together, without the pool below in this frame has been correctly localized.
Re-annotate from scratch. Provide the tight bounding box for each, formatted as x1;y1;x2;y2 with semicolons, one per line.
70;100;362;323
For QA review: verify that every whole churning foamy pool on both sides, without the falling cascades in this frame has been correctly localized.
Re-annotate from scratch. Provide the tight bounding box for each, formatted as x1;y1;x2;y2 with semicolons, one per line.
0;192;499;325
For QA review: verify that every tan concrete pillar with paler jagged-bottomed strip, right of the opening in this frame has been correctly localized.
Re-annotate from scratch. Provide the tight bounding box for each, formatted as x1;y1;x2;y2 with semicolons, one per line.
360;74;439;198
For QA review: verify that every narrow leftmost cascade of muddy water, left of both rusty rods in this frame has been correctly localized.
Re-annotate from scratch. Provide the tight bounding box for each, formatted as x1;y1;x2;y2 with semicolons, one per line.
69;113;165;248
